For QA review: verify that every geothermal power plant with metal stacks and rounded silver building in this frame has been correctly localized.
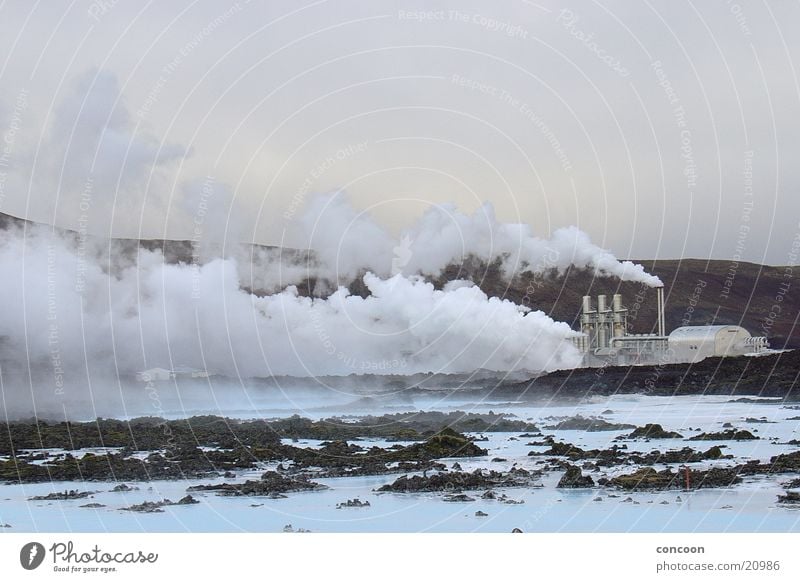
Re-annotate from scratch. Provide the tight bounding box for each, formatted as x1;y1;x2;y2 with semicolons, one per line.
572;287;769;367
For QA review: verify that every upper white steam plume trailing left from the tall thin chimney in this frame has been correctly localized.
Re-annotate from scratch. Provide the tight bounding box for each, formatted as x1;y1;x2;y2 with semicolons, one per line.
293;193;661;287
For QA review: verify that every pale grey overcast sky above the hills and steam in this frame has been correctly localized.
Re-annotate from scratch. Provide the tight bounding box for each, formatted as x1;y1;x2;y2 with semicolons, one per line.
0;0;800;264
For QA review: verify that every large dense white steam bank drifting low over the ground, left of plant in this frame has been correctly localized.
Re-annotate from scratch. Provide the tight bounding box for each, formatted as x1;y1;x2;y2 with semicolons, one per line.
0;227;579;377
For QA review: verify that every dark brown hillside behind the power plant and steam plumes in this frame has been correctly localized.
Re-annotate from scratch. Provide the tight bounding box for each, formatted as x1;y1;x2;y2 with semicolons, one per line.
0;214;800;348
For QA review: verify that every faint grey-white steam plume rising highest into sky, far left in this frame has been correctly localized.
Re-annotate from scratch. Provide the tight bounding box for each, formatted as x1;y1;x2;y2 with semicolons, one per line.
13;70;185;237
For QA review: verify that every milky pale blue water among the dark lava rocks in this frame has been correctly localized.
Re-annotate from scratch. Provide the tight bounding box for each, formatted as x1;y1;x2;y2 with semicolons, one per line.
0;396;800;532
